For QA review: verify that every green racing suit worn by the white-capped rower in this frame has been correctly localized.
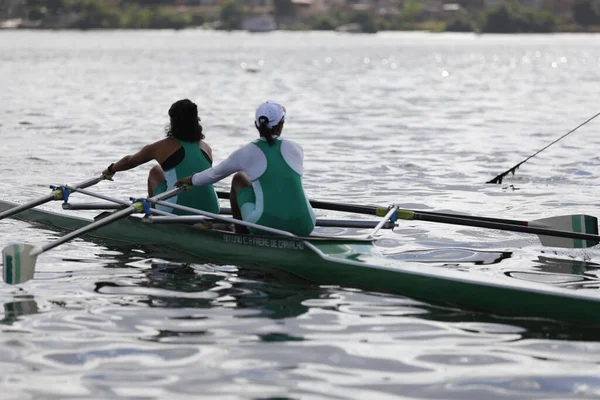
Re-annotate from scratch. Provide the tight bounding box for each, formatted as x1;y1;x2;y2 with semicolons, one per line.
253;139;314;236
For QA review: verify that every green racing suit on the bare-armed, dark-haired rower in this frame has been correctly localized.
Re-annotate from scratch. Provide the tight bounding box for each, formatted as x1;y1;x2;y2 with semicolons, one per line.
164;138;219;215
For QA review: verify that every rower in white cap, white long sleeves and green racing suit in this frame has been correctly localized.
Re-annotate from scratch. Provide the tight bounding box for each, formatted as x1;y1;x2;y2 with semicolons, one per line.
177;101;316;236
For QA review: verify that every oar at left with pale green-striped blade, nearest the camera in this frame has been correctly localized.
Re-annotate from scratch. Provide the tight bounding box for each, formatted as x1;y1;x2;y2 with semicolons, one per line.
2;187;184;285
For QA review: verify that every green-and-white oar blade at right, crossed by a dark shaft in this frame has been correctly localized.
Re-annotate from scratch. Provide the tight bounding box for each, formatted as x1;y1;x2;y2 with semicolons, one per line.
529;215;598;249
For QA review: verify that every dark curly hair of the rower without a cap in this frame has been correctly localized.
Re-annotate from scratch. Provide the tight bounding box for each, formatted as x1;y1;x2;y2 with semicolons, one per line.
166;99;204;142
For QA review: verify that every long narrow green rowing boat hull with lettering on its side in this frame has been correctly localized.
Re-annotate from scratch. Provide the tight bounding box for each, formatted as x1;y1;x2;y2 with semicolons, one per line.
0;197;600;324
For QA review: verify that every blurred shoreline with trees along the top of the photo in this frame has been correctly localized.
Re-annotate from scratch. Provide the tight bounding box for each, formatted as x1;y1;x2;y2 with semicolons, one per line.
0;0;600;34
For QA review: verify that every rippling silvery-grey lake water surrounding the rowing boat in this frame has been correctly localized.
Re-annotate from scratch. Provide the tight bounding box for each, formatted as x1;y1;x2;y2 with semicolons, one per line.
0;31;600;399
